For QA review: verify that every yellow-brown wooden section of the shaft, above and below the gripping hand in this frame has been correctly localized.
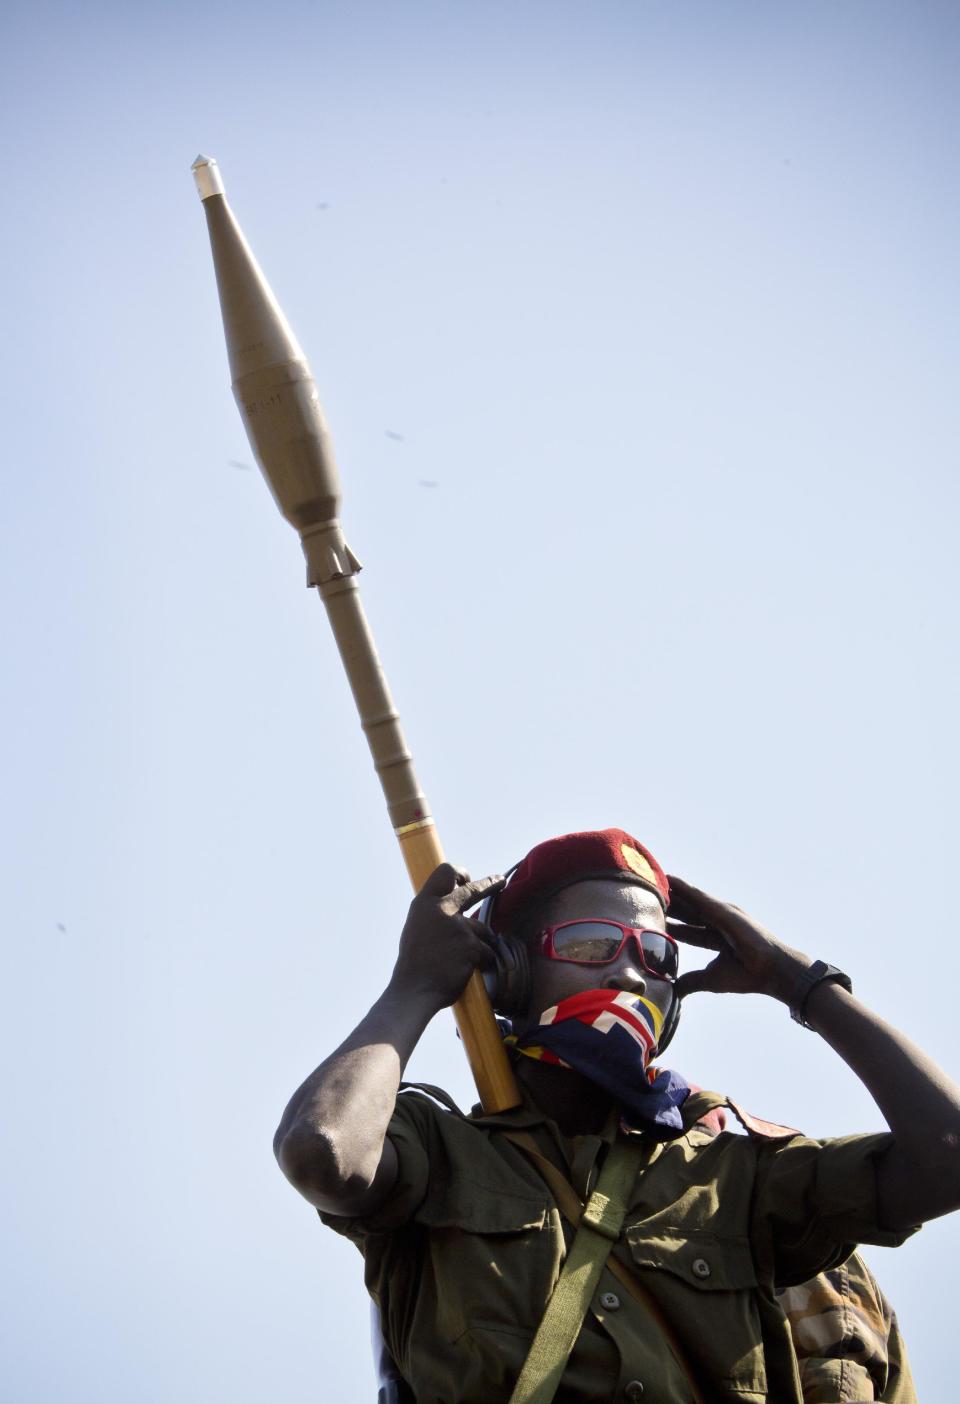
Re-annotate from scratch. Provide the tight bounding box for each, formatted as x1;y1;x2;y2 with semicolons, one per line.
397;820;522;1112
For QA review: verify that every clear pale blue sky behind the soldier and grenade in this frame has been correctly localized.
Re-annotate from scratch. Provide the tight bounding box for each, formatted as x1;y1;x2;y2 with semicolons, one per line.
0;0;960;1404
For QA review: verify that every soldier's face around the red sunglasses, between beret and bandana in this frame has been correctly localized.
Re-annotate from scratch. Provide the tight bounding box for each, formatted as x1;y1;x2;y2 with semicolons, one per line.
516;878;674;1032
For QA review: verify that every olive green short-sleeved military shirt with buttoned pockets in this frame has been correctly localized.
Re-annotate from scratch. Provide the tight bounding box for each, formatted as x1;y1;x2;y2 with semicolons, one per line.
321;1090;908;1404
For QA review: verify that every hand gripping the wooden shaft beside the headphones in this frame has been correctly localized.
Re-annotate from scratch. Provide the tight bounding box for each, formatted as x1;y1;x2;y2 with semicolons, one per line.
390;863;505;1011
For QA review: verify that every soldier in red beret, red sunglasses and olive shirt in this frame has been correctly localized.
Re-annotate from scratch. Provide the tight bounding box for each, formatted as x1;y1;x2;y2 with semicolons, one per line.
275;830;960;1404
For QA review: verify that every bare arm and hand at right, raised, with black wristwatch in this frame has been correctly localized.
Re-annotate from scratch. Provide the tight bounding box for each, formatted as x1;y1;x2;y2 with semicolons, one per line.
669;878;960;1230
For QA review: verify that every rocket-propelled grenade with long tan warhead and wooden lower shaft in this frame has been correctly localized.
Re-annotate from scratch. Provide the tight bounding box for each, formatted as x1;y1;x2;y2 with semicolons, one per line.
192;156;521;1112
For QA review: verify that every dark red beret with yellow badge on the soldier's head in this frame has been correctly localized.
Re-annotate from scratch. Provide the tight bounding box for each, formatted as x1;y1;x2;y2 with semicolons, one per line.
491;828;669;931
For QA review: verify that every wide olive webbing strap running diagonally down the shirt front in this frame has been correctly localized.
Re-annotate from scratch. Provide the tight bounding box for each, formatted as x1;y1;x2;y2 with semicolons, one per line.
508;1132;636;1404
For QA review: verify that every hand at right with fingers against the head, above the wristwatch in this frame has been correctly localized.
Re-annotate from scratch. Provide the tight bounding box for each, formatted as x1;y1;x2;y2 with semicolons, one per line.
667;875;811;1002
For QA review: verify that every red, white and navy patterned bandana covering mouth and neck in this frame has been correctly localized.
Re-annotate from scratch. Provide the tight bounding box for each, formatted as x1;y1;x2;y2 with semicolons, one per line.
507;990;691;1140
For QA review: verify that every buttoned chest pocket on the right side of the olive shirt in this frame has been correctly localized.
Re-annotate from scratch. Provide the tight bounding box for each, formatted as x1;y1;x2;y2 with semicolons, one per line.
626;1226;766;1396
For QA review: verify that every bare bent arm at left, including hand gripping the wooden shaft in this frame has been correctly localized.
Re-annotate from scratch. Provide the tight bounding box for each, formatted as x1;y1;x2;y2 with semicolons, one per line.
274;863;502;1214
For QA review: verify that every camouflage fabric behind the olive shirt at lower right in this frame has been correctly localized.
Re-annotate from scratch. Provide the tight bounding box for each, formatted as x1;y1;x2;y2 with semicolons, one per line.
778;1252;916;1404
